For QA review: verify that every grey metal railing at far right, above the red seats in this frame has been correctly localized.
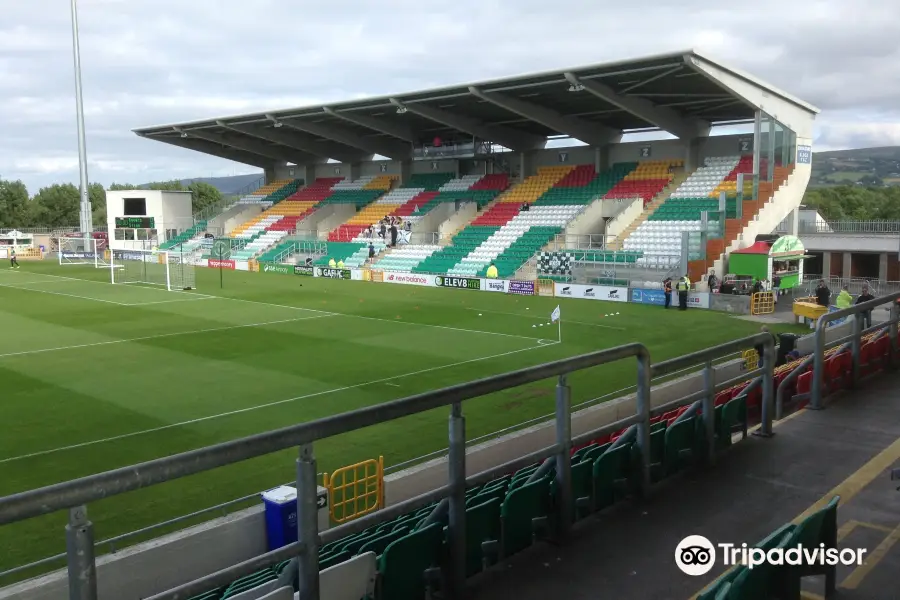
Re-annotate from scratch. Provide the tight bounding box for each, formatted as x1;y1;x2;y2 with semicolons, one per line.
809;292;900;410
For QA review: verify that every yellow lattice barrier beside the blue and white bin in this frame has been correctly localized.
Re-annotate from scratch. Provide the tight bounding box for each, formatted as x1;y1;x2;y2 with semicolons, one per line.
323;456;384;524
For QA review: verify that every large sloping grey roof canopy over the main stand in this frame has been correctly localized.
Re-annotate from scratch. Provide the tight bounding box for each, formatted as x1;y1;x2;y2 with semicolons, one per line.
135;50;819;168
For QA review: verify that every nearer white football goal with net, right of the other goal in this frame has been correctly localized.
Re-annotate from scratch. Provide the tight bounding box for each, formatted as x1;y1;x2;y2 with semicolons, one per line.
109;248;196;292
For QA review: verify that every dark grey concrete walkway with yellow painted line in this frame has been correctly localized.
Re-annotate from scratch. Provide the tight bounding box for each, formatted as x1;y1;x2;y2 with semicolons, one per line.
469;374;900;600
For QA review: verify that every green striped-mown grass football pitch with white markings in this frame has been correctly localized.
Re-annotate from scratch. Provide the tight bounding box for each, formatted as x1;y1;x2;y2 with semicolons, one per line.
0;262;788;574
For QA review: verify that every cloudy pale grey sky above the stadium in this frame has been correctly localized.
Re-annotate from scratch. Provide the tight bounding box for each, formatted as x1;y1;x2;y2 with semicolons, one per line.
0;0;900;193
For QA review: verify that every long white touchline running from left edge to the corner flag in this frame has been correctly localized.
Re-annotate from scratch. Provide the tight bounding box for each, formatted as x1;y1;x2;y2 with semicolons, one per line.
0;342;559;465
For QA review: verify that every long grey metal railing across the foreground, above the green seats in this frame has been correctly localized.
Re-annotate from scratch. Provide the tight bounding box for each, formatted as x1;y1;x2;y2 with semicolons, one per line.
0;334;774;600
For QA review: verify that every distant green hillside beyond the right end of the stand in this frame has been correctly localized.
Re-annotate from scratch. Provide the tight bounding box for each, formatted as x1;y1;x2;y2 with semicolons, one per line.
809;146;900;187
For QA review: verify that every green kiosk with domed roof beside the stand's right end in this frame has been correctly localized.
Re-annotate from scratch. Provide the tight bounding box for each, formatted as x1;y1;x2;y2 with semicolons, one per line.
728;235;809;290
